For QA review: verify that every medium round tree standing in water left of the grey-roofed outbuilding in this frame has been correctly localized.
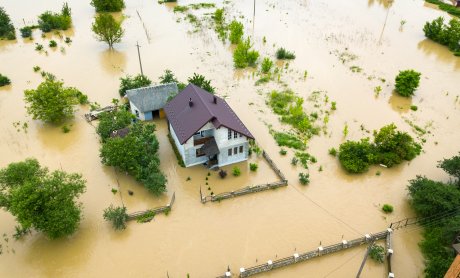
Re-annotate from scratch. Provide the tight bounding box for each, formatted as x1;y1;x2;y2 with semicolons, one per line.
24;78;82;123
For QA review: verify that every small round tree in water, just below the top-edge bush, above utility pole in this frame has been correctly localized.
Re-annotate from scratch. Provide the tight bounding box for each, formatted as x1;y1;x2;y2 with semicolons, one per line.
91;13;124;48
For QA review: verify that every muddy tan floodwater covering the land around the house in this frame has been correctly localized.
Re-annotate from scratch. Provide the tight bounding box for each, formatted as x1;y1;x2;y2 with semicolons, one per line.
0;0;460;277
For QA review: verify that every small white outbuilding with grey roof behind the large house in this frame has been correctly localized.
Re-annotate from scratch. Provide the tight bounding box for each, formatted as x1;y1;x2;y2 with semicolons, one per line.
126;83;178;121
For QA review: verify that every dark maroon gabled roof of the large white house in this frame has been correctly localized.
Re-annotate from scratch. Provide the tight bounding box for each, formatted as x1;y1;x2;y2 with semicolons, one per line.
164;84;254;144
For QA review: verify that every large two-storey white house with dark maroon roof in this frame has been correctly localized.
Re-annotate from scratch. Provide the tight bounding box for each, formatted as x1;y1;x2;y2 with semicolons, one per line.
164;84;254;167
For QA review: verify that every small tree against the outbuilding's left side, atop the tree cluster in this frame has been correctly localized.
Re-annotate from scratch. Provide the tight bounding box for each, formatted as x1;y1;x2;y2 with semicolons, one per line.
96;109;134;141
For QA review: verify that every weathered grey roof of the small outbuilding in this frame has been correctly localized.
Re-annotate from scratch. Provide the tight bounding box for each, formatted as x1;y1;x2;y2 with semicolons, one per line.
126;83;179;113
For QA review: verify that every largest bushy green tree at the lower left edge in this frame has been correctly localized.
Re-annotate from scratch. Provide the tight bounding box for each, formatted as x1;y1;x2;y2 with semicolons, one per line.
0;159;86;239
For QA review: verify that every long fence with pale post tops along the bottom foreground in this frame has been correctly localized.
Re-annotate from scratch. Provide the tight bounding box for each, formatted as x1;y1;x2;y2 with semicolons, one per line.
217;229;393;278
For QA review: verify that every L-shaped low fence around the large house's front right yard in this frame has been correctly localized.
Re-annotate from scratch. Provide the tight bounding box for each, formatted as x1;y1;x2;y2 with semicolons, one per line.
200;151;287;204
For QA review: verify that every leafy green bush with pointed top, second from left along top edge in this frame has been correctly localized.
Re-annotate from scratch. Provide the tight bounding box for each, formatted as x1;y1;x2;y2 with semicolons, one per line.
38;3;72;32
